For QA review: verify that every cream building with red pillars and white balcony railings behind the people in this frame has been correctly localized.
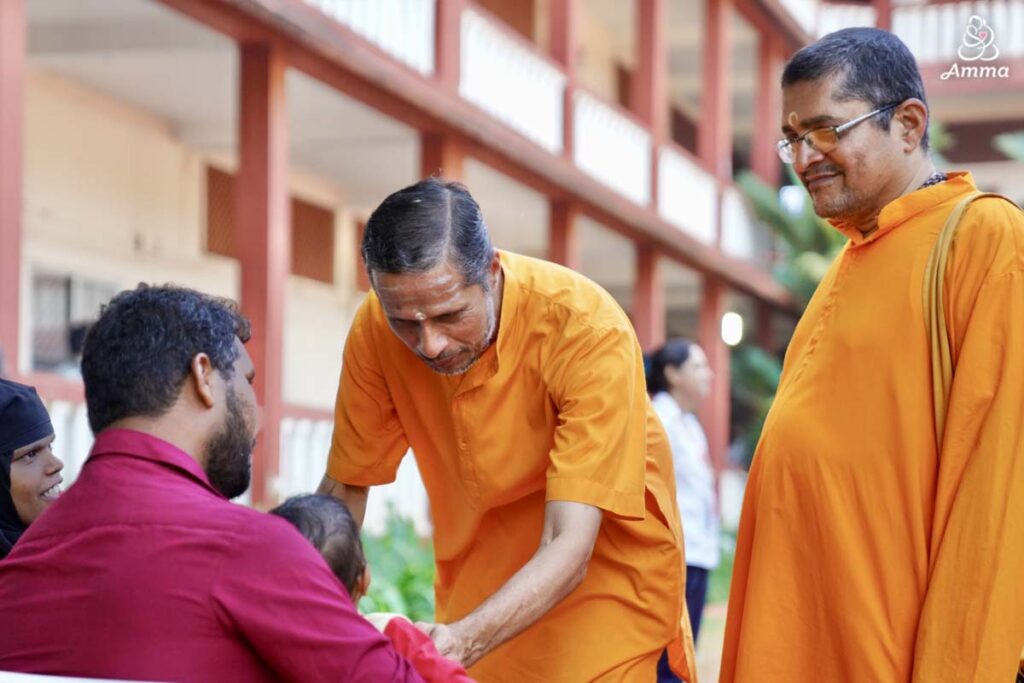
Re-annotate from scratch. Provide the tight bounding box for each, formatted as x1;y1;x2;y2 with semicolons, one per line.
0;0;1024;528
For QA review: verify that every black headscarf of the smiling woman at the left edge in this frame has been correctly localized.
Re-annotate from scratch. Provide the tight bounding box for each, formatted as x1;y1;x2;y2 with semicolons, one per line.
0;379;53;558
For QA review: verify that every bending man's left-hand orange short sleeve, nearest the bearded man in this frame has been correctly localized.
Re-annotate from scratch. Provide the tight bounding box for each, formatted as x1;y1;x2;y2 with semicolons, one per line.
327;294;409;486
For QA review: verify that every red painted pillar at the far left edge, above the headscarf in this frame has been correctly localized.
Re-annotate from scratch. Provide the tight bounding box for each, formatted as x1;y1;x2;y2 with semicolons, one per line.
0;0;27;376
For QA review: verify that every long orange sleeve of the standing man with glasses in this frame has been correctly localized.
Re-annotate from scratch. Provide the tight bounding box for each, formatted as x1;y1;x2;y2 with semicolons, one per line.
912;201;1024;683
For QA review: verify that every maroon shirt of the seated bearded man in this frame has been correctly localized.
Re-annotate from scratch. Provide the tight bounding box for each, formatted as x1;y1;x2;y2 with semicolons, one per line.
0;430;422;683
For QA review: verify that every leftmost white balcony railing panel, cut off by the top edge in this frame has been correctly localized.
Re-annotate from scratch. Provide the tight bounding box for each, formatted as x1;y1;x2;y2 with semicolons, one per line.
305;0;436;75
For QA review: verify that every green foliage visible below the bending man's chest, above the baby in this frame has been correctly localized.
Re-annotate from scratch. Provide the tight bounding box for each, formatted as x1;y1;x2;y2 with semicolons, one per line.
359;506;434;622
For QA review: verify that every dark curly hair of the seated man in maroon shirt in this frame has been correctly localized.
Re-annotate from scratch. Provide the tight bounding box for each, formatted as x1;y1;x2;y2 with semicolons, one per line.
82;284;250;434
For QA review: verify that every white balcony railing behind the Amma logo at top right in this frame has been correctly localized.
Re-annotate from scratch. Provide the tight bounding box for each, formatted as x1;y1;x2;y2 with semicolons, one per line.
893;0;1024;66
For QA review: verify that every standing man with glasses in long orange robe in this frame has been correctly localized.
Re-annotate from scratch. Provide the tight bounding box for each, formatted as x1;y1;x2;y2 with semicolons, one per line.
721;29;1024;683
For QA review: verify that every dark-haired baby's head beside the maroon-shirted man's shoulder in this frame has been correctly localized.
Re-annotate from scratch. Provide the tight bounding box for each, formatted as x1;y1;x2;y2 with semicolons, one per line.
270;494;370;602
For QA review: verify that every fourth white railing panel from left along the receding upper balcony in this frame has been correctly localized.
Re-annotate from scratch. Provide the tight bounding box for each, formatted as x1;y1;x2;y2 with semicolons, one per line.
657;147;718;245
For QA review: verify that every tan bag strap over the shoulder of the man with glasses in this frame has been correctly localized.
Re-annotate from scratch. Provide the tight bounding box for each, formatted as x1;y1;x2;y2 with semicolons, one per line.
925;193;1018;450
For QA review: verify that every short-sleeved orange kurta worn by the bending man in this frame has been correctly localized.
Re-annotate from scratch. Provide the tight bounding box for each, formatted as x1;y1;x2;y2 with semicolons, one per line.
328;252;693;683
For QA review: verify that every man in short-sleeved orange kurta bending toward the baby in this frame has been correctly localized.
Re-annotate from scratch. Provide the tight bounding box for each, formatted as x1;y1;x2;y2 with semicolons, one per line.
321;178;695;683
